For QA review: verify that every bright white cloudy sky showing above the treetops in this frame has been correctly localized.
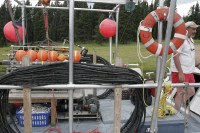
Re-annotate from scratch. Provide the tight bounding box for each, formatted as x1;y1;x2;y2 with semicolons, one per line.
0;0;200;16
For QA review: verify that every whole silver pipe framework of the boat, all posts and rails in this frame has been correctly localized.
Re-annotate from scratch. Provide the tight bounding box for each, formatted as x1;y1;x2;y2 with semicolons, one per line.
6;0;200;133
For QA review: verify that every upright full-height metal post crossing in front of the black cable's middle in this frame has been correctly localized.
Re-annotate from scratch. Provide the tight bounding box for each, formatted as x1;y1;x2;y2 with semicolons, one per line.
68;0;74;133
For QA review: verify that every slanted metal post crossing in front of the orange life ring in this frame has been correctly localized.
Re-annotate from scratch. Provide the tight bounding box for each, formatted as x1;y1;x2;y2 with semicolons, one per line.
150;0;176;133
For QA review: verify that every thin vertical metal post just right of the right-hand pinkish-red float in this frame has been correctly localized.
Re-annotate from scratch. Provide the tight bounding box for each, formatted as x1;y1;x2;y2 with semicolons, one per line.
114;7;120;59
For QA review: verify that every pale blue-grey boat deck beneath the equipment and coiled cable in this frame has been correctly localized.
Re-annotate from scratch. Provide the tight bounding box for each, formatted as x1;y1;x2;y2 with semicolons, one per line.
13;99;200;133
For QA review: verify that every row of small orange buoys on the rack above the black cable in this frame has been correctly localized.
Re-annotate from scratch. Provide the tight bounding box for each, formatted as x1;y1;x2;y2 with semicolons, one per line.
15;50;81;62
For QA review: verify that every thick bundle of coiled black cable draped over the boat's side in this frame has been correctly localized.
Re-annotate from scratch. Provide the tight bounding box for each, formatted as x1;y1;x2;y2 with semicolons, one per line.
0;62;146;133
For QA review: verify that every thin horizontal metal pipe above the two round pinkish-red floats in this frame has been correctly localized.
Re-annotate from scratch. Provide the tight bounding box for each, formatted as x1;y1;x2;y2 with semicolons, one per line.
22;5;115;12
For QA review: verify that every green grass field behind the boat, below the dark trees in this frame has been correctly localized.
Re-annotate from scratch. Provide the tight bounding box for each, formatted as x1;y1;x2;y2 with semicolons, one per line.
0;40;200;77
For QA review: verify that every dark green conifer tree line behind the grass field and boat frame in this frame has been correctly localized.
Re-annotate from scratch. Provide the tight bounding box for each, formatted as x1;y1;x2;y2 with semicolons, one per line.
0;0;200;46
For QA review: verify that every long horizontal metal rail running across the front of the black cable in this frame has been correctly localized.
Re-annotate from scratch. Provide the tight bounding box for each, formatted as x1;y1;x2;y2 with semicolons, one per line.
0;83;200;89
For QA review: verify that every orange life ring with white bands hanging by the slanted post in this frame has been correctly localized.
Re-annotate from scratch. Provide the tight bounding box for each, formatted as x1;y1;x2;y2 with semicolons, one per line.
139;7;187;56
